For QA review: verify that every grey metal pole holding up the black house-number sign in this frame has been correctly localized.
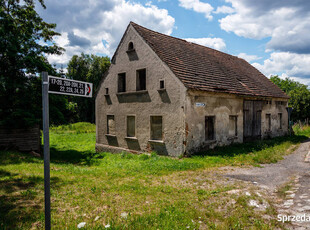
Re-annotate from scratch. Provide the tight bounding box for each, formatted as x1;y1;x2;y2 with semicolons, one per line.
42;72;51;230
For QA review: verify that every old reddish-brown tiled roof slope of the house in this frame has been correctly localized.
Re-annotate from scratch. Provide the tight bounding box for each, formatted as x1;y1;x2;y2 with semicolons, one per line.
130;22;288;98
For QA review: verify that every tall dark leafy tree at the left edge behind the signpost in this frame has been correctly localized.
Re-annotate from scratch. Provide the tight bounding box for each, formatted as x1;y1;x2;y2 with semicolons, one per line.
0;0;63;127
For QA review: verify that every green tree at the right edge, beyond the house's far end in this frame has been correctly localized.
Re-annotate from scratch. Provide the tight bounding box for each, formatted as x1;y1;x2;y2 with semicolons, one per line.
270;76;310;121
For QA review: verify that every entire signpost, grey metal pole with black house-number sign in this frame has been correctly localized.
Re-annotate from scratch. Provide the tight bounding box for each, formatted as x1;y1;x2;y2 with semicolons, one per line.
42;72;93;230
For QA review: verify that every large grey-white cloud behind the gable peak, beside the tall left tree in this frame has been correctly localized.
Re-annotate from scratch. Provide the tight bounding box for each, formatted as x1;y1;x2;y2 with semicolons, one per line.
37;0;175;64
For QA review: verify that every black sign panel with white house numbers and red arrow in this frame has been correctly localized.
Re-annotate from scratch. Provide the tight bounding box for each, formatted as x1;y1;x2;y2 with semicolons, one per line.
48;76;93;97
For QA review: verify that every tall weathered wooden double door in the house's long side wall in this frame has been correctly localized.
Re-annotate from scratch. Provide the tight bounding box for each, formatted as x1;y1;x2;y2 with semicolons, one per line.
243;100;263;141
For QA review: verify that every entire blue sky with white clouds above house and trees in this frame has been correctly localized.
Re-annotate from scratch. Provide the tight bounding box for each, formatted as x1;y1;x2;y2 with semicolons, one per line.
37;0;310;85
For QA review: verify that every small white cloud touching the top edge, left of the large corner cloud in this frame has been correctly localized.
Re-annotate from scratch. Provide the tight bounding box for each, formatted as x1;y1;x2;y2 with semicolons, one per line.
179;0;213;20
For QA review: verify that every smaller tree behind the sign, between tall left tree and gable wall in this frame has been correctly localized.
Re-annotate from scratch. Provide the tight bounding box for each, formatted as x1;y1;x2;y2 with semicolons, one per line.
67;53;110;123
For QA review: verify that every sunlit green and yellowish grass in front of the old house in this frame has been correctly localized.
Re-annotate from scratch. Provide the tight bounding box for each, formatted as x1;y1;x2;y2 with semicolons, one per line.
0;123;310;229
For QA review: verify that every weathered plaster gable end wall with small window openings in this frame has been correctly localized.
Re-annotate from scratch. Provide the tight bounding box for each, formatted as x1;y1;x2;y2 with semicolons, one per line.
96;26;186;156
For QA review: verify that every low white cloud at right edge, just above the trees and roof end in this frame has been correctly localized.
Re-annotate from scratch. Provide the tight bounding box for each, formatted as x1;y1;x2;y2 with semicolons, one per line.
252;52;310;82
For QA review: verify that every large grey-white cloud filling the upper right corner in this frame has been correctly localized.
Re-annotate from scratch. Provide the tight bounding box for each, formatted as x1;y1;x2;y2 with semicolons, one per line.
219;0;310;54
